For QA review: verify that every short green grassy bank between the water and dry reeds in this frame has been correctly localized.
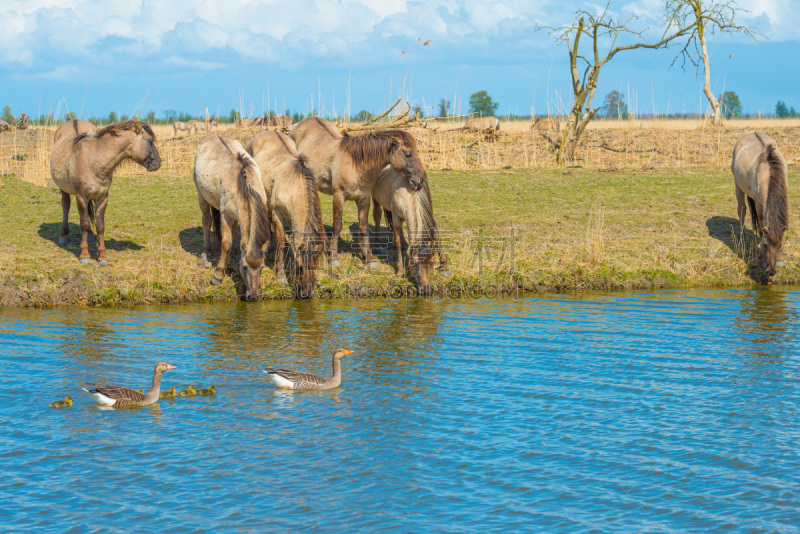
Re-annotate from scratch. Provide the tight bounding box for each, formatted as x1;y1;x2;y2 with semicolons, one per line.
0;167;800;306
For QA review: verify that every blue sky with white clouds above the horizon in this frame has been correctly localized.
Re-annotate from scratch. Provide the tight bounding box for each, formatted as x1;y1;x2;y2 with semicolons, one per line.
0;0;800;118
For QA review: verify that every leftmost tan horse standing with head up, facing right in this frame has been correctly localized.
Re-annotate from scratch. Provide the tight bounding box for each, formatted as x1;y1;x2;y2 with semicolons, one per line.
50;120;161;265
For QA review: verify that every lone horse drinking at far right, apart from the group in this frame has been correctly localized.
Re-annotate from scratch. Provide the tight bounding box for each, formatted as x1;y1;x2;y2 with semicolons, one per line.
731;132;789;276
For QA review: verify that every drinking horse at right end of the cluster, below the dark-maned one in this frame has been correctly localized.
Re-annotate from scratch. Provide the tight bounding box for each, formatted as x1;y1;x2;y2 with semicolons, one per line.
372;167;451;295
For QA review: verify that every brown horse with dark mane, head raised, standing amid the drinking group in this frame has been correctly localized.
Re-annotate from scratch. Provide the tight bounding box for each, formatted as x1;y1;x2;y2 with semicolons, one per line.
289;117;428;267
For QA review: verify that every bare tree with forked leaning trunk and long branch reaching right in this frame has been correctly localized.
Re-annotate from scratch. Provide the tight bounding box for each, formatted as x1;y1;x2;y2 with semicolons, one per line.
546;0;697;161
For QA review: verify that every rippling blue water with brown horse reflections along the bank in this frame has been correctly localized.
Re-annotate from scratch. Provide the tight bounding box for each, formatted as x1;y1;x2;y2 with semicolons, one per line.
0;288;800;533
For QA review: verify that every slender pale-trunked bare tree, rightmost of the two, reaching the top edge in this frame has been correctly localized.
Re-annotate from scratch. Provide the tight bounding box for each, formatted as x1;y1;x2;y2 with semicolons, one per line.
667;0;757;125
